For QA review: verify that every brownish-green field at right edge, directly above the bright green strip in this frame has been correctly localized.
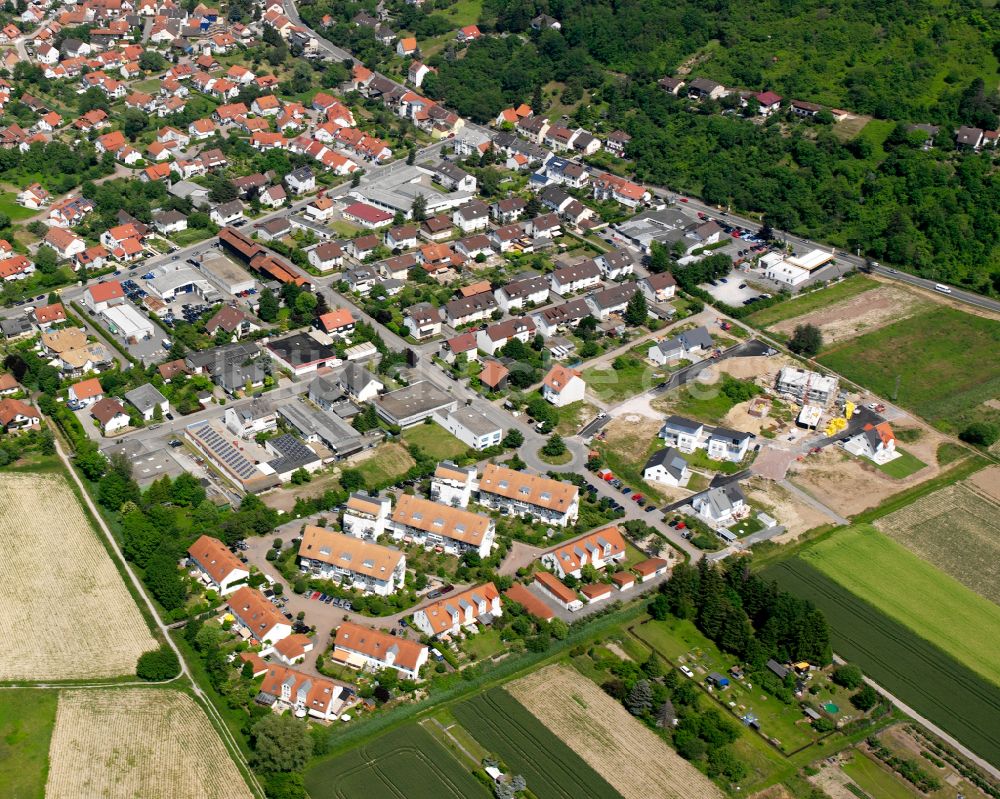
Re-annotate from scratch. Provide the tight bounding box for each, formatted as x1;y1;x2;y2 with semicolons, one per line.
875;481;1000;605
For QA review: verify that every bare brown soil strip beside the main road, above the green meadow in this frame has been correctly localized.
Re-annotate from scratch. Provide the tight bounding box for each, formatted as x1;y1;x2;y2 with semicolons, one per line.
772;285;930;344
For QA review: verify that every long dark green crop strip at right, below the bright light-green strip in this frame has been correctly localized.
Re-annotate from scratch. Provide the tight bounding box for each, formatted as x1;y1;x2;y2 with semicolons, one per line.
764;557;1000;762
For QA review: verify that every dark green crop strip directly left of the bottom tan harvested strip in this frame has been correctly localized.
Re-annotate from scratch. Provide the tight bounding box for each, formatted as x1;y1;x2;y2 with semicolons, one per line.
452;688;620;799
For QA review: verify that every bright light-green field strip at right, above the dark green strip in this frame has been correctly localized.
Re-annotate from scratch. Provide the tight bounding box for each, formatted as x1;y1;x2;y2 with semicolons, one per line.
799;525;1000;685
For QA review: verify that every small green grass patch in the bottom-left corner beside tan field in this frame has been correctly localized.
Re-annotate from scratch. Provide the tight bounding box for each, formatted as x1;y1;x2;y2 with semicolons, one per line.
0;688;58;799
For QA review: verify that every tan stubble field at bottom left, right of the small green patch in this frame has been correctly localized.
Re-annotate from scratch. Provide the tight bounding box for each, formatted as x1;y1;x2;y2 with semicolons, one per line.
45;688;253;799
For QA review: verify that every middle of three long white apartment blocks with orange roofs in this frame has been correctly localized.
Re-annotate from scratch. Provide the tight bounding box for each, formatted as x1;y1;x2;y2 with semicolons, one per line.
391;494;496;558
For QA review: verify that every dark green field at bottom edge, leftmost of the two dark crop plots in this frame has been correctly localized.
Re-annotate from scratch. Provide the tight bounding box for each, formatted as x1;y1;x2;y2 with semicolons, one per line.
305;724;489;799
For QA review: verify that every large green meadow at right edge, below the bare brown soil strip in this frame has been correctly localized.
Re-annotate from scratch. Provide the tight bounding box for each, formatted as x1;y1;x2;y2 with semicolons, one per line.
818;307;1000;433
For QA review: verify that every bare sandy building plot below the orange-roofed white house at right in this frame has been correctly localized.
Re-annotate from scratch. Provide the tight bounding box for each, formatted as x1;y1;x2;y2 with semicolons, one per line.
789;446;940;516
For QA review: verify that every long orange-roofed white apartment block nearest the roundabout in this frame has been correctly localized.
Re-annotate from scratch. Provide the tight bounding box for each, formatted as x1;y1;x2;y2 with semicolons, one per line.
479;463;580;527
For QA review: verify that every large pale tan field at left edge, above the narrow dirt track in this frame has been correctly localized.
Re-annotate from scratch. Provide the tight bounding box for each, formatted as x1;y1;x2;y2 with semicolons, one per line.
0;473;156;681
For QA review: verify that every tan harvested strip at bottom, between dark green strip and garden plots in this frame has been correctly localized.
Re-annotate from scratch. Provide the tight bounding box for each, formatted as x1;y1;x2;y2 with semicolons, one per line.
507;665;722;799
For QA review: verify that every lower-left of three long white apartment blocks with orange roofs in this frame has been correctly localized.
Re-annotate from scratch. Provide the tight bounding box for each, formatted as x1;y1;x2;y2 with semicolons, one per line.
299;524;406;596
